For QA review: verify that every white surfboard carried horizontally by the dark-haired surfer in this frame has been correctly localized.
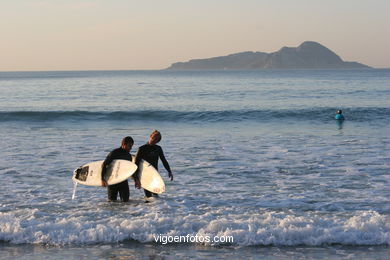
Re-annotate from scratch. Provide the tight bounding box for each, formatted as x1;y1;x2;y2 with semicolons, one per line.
72;160;138;186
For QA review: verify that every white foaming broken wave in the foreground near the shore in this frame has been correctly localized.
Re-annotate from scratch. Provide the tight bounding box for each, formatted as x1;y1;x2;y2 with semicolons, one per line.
0;209;390;246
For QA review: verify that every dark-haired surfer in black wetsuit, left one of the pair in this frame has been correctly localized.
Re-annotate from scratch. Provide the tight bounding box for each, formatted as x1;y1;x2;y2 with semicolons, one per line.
102;136;141;202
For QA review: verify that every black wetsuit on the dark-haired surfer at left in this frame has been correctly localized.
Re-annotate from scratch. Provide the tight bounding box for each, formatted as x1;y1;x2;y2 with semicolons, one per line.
102;147;136;202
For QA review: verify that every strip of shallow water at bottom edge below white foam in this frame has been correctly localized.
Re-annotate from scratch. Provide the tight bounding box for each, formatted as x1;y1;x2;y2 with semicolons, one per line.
0;241;390;259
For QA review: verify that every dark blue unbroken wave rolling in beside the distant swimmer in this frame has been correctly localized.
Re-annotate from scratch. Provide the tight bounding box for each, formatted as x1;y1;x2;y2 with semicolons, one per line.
0;107;390;122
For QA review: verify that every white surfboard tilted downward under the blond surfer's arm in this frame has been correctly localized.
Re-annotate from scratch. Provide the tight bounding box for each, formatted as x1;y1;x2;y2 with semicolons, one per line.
133;155;165;194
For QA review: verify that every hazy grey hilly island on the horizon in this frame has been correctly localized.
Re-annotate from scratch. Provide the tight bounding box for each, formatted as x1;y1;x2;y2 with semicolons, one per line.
167;41;371;70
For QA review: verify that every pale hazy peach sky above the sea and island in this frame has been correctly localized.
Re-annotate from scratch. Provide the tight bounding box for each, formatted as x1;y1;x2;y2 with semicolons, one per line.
0;0;390;71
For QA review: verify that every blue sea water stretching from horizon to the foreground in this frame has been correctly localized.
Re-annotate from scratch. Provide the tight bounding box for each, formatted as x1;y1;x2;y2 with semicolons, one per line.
0;69;390;259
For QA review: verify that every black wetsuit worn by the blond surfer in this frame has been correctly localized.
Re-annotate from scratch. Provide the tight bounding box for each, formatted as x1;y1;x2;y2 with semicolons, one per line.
134;144;171;198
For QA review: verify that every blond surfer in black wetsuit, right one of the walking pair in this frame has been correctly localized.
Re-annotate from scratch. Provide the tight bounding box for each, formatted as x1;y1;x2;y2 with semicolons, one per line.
134;130;173;198
